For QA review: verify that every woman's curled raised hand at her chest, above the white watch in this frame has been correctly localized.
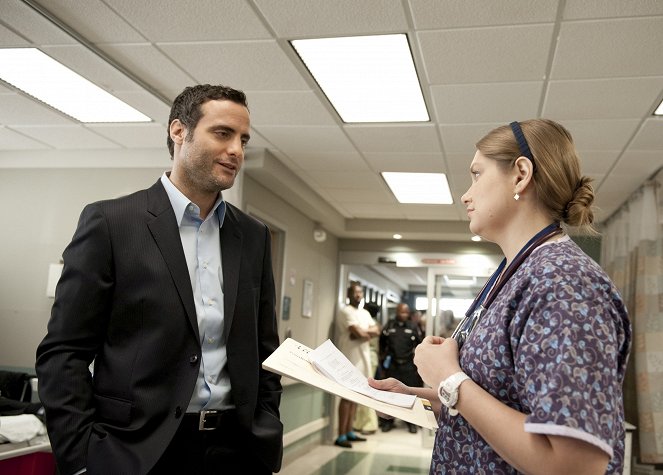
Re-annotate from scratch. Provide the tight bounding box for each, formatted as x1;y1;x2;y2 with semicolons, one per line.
414;336;462;388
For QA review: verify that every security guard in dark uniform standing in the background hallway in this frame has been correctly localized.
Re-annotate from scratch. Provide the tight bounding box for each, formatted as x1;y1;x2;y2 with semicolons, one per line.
380;303;423;434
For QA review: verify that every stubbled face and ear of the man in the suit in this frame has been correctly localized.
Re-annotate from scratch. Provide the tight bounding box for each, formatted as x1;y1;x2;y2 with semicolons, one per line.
170;100;251;198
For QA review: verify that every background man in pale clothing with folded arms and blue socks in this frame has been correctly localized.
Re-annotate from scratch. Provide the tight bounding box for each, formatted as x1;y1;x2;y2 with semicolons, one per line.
334;281;380;448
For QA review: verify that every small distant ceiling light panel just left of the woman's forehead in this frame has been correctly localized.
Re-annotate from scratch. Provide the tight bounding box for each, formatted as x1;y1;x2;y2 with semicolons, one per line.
382;172;453;205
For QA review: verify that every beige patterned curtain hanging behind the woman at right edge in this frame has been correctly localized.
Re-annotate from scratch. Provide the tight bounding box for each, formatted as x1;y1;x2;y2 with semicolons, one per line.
601;169;663;464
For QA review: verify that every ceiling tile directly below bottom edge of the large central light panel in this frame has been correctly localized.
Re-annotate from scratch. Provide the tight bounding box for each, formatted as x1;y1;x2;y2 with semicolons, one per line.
345;123;440;153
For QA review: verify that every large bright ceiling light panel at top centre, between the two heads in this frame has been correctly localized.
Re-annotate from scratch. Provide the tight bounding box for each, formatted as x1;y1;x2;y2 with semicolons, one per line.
291;34;429;122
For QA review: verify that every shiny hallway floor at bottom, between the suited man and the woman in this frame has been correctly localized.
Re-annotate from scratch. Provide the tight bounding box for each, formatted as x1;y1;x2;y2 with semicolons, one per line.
279;421;433;475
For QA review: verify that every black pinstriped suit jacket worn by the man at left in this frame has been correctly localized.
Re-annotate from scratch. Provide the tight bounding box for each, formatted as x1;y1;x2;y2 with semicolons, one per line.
36;181;283;475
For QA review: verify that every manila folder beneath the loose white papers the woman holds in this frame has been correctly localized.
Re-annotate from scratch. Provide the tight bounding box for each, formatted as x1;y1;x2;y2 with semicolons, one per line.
262;338;437;430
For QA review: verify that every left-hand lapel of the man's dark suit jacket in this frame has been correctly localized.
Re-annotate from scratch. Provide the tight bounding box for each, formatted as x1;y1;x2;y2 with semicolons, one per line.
147;180;200;341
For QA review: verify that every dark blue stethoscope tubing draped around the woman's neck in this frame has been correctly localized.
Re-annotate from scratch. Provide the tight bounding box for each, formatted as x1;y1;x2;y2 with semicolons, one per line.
451;223;562;348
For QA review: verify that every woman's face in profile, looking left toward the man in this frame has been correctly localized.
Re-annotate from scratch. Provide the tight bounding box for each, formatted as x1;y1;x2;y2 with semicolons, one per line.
460;151;517;242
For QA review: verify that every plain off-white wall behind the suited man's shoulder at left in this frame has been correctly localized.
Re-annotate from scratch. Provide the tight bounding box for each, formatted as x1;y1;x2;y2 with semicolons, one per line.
0;168;163;368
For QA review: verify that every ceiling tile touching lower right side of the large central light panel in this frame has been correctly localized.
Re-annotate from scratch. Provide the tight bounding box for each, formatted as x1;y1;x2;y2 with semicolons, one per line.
431;81;543;124
